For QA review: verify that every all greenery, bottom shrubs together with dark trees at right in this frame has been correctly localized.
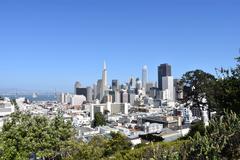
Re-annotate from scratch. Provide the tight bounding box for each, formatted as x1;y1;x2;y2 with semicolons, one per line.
0;58;240;160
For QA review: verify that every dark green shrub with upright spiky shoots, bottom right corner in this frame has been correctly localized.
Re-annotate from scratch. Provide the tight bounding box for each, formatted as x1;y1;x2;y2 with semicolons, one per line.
188;112;240;159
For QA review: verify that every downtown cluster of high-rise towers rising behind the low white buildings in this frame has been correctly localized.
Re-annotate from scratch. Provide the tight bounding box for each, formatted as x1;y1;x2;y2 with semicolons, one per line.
70;62;181;106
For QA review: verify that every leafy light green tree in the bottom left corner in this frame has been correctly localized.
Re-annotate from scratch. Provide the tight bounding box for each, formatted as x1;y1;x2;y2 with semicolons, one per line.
0;112;74;160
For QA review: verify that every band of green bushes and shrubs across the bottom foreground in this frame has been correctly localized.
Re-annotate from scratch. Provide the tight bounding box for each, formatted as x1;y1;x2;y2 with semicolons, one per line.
0;112;240;160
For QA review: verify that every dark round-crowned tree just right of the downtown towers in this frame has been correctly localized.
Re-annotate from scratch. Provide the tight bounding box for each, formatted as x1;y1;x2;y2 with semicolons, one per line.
179;70;216;115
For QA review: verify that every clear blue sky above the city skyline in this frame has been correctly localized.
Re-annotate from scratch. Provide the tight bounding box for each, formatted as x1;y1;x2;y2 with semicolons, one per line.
0;0;240;91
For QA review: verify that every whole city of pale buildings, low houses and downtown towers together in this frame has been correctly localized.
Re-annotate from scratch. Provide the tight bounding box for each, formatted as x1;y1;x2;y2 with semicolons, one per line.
0;62;207;145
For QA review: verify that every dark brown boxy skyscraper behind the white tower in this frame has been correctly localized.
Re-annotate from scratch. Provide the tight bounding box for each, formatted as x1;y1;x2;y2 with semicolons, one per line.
158;63;172;90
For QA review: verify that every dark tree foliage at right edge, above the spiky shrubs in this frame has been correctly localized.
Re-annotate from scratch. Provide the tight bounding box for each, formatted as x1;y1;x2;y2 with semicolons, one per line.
179;57;240;114
